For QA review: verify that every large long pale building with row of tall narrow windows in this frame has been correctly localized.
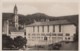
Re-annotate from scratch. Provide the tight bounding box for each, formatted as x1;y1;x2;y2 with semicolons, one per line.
26;20;76;46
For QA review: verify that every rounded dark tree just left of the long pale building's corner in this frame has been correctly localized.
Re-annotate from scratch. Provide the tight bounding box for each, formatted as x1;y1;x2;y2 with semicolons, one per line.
14;36;27;49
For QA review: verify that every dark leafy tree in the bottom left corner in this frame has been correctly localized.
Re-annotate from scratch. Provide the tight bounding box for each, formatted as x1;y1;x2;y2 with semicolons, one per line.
2;35;13;49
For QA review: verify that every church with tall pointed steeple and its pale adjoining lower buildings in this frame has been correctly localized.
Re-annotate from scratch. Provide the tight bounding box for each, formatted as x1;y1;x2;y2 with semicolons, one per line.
2;5;25;39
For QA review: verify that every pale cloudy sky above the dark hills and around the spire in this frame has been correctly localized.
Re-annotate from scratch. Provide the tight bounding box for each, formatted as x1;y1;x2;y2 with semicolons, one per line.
3;2;78;16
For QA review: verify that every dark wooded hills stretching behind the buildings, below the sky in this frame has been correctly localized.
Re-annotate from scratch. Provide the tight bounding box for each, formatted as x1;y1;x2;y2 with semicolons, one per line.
2;13;78;25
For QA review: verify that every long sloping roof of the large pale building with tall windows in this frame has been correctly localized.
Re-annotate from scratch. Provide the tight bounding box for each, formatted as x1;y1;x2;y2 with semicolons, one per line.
27;20;72;26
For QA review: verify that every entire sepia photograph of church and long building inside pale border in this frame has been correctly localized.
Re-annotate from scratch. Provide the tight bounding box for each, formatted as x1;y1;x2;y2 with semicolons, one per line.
2;2;79;51
